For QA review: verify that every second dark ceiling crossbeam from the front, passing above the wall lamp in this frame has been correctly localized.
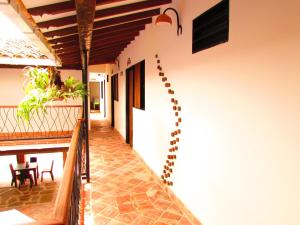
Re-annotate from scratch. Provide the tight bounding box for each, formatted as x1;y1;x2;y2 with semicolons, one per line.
37;0;172;28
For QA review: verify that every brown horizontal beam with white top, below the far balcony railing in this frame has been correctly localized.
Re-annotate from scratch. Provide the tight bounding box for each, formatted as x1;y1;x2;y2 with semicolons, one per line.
0;143;70;165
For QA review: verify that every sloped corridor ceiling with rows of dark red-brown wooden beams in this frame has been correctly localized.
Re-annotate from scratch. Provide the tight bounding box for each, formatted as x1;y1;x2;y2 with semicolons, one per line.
23;0;172;69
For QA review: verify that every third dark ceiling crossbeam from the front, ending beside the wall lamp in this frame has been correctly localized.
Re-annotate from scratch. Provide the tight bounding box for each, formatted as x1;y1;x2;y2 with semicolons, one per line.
44;9;160;37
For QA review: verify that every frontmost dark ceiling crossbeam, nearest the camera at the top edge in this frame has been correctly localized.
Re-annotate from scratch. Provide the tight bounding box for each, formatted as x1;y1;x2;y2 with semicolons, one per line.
28;0;124;16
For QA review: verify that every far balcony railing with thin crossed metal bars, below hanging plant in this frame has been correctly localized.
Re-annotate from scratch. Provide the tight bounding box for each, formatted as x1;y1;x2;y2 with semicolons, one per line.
0;105;81;141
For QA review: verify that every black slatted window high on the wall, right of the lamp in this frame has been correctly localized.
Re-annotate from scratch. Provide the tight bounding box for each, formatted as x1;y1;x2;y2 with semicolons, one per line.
193;0;229;54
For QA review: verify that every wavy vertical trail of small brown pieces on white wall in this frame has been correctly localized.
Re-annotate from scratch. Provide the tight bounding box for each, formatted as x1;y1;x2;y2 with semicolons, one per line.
155;55;182;186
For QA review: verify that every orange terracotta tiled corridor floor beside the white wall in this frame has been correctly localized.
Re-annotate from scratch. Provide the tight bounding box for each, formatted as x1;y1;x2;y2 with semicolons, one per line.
84;121;200;225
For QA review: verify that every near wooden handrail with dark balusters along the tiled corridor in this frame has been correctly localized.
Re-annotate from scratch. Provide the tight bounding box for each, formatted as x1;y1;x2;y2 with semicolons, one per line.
24;111;84;225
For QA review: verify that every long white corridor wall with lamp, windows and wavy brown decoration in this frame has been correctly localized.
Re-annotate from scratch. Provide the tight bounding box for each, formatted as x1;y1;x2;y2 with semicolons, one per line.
111;0;300;225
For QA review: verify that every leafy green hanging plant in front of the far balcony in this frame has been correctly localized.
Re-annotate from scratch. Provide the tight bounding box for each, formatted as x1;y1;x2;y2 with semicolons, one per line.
17;67;87;122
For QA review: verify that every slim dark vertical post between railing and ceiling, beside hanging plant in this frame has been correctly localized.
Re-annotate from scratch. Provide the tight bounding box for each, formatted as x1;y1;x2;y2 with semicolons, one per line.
82;50;90;183
